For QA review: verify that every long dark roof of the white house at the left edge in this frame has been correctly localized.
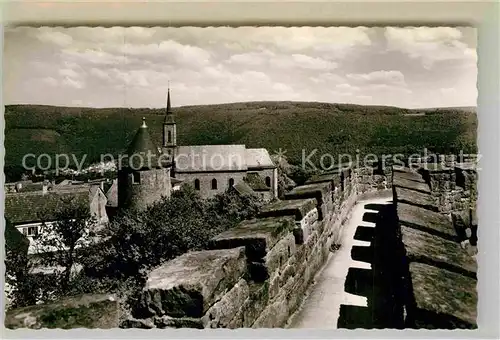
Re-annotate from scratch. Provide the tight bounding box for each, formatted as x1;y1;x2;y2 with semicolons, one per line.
5;187;91;224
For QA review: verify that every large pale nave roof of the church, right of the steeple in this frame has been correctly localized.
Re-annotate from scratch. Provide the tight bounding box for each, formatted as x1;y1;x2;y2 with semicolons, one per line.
175;144;247;173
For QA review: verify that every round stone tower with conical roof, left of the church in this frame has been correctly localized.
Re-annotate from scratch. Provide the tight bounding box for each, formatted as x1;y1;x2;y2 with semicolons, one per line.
118;118;172;210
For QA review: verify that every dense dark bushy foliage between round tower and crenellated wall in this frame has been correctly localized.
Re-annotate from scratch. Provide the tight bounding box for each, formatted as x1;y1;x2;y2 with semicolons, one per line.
86;185;260;282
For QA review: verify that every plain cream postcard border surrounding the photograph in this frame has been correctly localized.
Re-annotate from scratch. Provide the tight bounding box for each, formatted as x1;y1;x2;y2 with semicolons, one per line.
0;0;500;339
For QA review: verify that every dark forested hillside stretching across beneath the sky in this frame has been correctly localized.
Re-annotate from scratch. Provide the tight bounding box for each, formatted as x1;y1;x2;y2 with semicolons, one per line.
5;102;477;170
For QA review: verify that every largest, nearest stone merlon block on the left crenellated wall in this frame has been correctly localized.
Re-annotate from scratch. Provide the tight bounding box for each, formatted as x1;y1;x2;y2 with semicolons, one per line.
133;247;246;318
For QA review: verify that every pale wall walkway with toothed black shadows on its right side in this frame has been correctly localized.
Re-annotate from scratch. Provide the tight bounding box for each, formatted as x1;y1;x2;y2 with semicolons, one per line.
289;198;392;329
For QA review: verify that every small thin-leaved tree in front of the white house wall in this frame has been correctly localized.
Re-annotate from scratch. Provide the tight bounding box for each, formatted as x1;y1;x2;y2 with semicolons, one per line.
34;202;96;293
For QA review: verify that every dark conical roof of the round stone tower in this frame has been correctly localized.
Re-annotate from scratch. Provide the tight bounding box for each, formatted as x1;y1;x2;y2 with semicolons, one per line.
126;118;164;170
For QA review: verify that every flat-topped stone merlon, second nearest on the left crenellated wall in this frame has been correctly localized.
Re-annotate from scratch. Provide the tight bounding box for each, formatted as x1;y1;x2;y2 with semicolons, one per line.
208;217;295;262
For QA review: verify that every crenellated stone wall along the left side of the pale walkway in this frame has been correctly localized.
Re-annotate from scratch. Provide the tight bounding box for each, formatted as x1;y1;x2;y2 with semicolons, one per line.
122;165;390;328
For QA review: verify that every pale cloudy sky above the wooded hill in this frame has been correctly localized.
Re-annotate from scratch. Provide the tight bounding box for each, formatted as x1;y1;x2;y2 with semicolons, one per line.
4;27;477;108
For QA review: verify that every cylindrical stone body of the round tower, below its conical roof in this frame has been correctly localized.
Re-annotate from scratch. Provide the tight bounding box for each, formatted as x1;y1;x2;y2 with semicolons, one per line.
118;168;172;210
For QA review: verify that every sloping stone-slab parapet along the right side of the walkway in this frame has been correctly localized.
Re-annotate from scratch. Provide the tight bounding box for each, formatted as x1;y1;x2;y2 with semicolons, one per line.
393;169;477;329
